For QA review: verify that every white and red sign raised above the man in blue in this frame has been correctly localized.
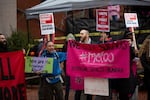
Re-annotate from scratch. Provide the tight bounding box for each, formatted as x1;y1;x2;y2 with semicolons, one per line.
39;13;55;35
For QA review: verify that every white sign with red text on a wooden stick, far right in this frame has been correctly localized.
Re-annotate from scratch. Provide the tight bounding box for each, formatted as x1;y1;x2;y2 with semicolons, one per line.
124;13;139;27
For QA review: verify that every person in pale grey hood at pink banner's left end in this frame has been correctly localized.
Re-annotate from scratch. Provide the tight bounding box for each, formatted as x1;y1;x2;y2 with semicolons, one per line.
62;33;75;100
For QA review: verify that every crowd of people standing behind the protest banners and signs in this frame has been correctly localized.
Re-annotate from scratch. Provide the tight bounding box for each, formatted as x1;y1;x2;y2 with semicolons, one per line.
0;28;150;100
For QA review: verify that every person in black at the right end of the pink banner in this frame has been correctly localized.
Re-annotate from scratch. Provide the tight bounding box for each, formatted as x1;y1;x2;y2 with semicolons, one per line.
113;31;137;100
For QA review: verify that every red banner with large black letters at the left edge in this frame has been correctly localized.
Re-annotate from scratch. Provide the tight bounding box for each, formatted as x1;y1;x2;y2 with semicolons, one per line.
0;51;27;100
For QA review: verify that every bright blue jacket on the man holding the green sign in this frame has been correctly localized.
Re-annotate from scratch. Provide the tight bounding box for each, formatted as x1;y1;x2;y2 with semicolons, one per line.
41;50;66;83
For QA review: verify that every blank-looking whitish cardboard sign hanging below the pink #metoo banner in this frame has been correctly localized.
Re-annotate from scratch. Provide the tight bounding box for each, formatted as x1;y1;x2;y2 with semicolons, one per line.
84;77;109;96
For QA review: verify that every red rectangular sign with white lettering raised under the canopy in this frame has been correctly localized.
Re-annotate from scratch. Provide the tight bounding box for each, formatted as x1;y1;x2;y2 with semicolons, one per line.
96;9;109;32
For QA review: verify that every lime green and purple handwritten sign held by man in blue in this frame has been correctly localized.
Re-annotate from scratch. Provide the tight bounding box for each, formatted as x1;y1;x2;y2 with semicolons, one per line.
25;57;53;73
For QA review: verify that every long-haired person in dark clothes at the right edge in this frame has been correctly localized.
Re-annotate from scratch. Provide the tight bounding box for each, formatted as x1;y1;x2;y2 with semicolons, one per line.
139;35;150;100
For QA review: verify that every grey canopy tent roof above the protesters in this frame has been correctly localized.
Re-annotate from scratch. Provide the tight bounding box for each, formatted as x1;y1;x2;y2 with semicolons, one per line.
26;0;150;19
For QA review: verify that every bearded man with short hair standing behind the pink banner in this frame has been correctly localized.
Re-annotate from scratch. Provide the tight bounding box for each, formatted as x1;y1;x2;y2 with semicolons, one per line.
75;28;94;100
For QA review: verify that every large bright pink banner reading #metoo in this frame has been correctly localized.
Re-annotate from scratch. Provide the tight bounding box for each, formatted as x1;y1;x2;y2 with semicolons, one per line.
67;41;130;78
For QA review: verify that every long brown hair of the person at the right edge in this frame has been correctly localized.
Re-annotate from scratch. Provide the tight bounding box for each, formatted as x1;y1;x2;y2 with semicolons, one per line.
139;35;150;61
